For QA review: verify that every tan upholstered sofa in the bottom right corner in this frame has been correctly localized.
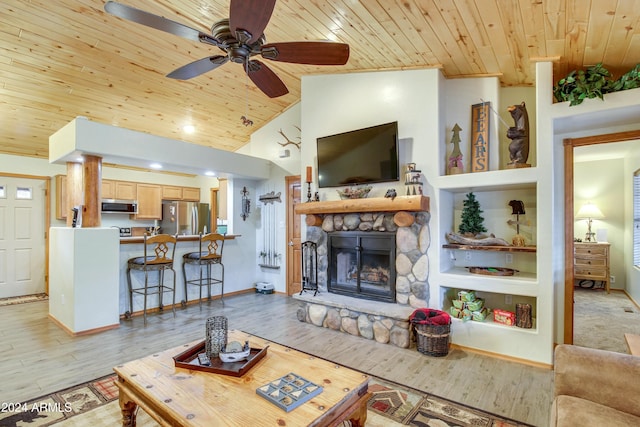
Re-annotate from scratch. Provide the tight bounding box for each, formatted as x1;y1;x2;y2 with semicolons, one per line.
549;344;640;427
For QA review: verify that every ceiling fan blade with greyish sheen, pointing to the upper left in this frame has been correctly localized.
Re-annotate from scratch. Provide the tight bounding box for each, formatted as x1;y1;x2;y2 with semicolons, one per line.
104;1;220;46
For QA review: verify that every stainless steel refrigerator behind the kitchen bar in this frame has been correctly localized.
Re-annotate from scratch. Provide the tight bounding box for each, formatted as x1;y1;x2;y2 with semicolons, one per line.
160;201;210;235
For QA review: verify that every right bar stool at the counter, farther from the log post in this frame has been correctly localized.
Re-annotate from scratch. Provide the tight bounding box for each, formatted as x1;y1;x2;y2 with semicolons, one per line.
182;233;224;305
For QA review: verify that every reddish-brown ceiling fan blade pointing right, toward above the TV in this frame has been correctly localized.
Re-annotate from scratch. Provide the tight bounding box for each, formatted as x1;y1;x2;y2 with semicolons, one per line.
260;41;349;65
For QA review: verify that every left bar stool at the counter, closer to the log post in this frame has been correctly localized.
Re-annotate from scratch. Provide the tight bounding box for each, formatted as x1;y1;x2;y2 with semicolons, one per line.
127;234;178;324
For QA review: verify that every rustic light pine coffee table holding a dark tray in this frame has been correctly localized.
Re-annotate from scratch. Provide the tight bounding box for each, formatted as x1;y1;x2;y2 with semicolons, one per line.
114;331;370;427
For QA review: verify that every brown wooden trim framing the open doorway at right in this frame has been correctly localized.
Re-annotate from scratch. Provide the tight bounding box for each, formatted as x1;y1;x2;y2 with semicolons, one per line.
563;130;640;344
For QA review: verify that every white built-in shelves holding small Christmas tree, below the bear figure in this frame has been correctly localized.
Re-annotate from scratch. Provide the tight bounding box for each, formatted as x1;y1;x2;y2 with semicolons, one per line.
437;162;540;358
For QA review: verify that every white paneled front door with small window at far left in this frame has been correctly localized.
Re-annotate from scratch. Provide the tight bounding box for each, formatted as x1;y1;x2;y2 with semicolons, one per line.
0;176;46;298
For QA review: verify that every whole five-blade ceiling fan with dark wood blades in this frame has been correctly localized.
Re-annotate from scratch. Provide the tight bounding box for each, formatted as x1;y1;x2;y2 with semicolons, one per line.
104;0;349;98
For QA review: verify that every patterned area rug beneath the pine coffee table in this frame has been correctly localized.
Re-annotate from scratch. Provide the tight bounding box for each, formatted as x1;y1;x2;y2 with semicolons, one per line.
0;374;531;427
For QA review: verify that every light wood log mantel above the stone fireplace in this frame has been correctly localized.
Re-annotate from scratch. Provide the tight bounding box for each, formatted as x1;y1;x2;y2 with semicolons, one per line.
294;195;429;215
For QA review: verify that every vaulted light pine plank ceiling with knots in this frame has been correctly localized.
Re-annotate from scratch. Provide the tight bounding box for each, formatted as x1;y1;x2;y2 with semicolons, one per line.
0;0;640;162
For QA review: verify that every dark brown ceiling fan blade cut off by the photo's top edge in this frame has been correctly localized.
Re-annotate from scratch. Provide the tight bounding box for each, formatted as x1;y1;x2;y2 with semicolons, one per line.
229;0;276;44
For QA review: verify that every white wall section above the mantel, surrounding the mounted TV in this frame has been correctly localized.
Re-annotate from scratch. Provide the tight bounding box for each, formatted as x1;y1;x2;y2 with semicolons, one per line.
299;69;442;204
